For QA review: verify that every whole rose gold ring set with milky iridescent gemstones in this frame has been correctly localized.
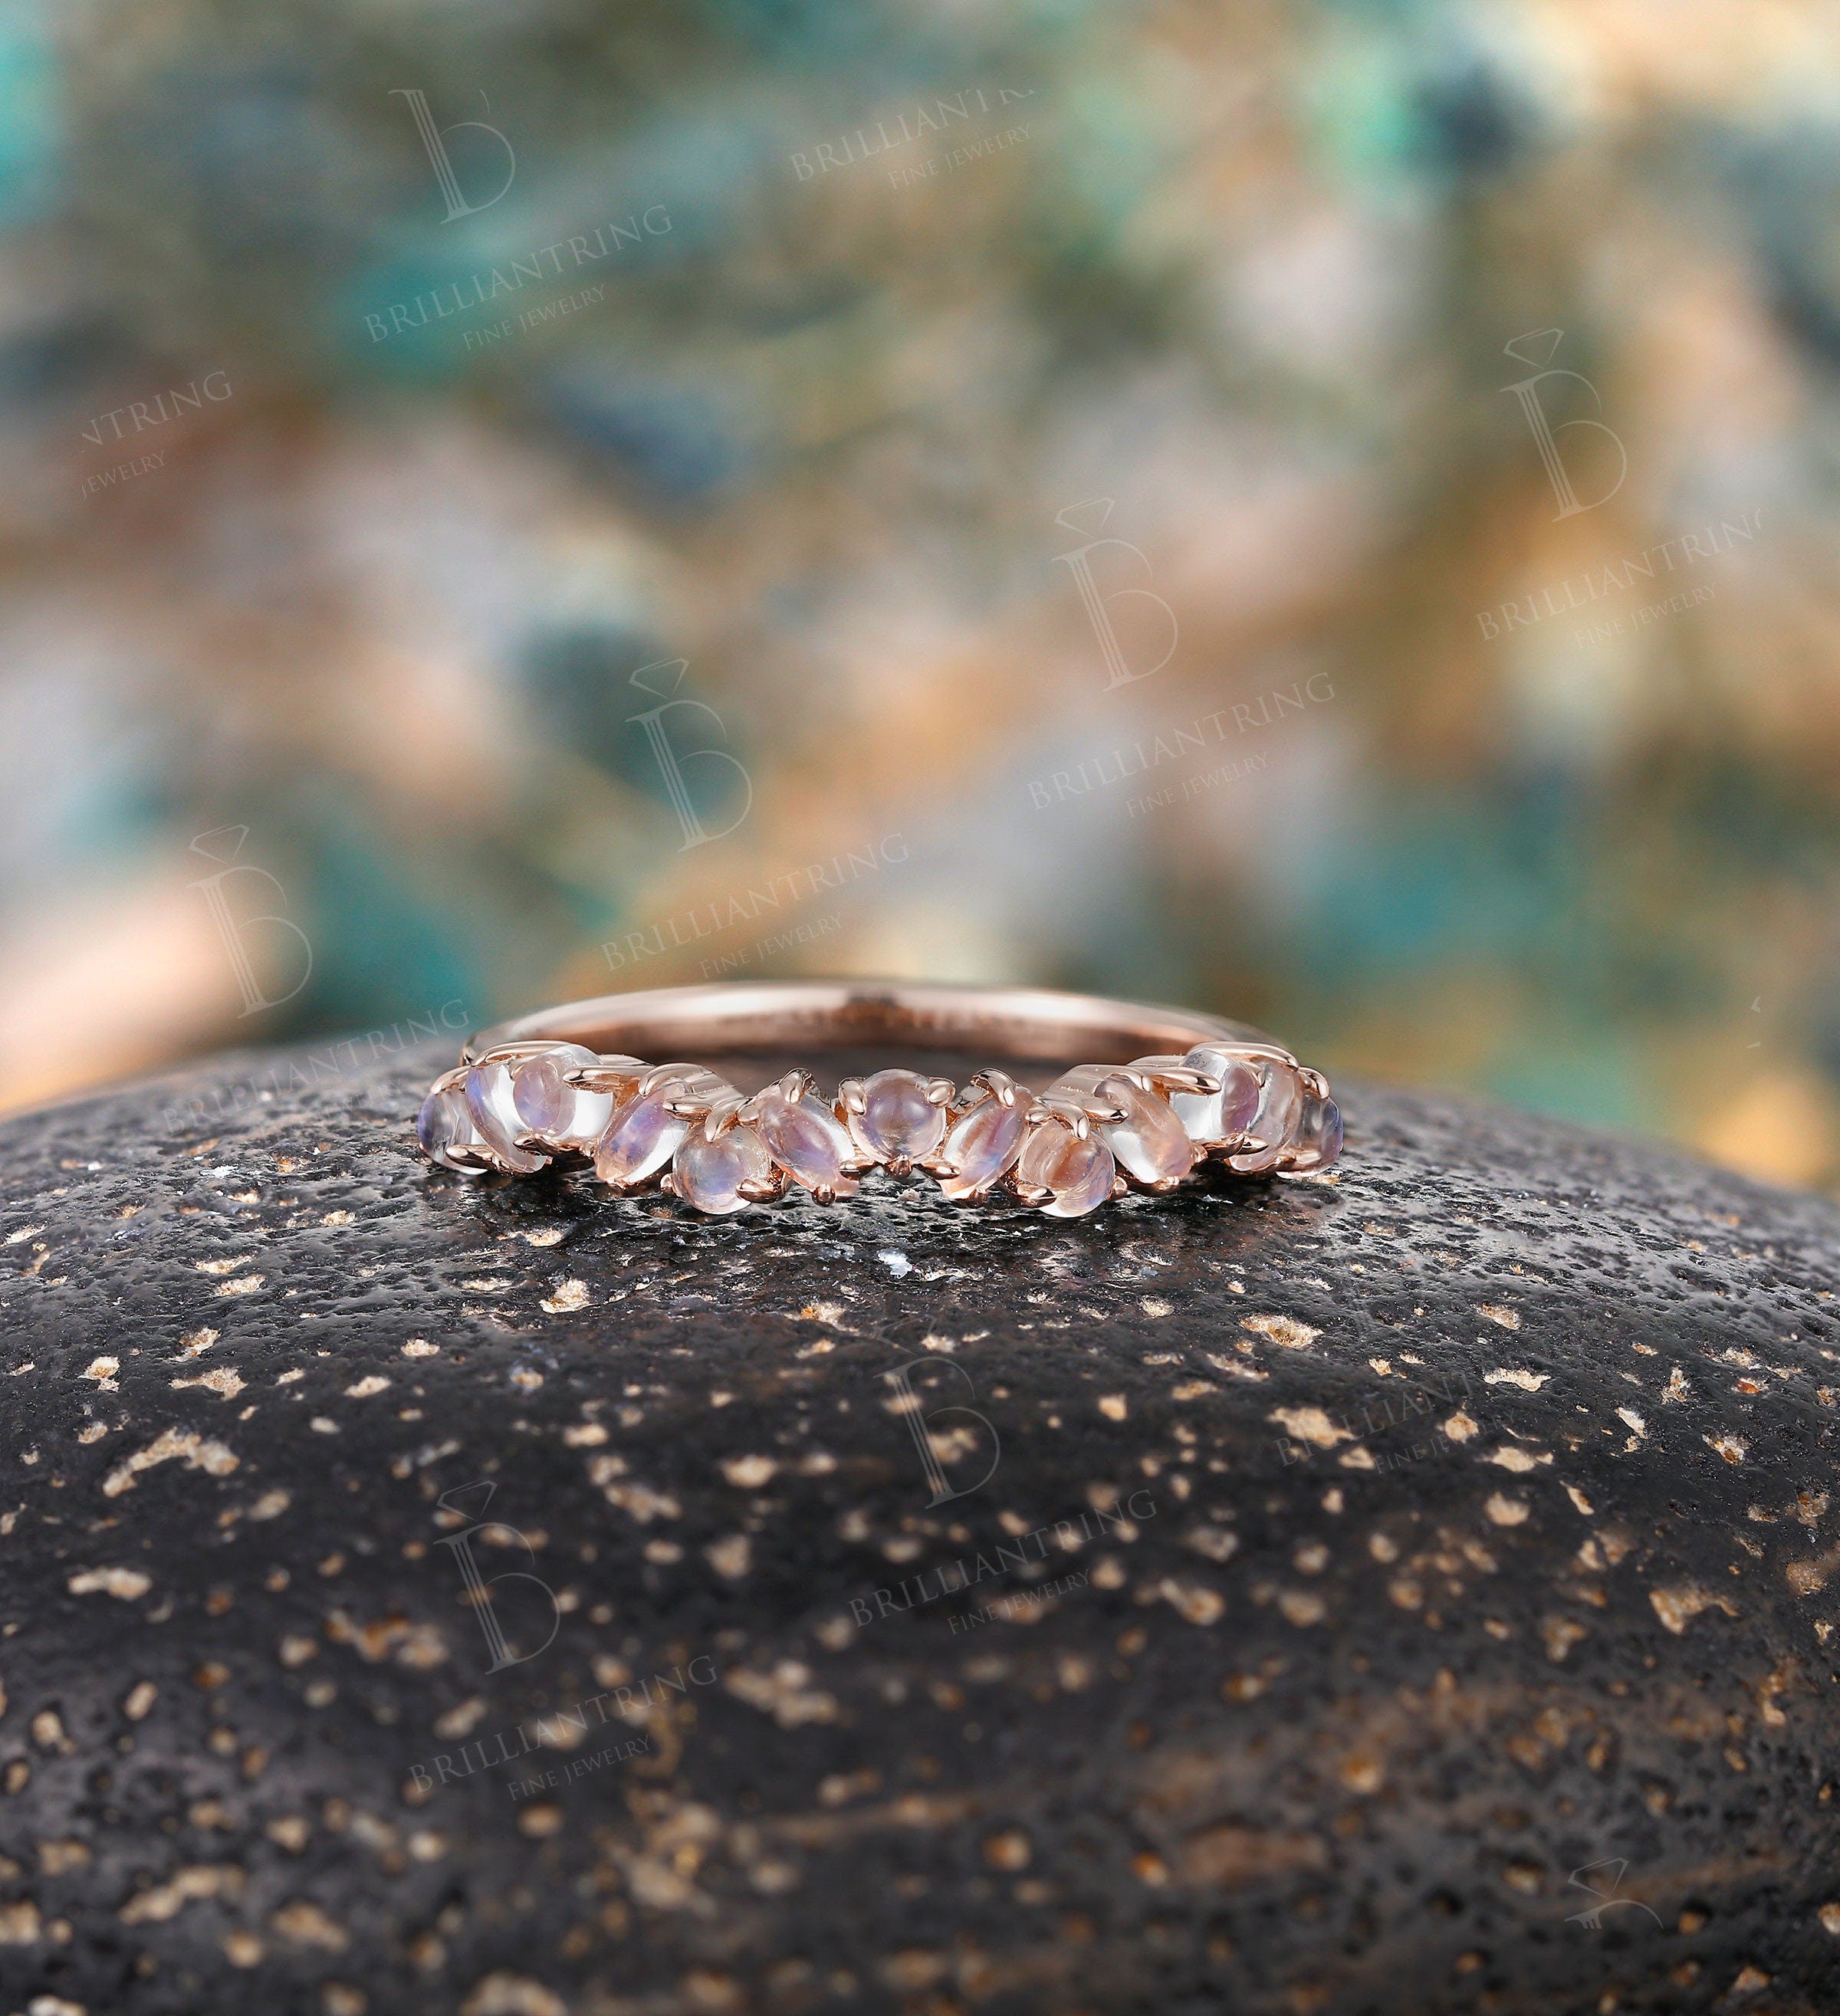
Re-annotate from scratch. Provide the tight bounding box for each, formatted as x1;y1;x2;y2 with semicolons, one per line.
416;980;1342;1218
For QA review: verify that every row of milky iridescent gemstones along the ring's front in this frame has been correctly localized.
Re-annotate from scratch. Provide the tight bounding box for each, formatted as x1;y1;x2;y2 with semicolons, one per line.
417;1042;1342;1218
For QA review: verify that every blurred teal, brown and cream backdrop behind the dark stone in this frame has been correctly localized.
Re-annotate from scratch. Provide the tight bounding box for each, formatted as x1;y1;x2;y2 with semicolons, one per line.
0;0;1840;1184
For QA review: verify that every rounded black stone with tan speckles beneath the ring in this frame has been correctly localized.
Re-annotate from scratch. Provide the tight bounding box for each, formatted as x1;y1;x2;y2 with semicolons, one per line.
0;1054;1840;2016
